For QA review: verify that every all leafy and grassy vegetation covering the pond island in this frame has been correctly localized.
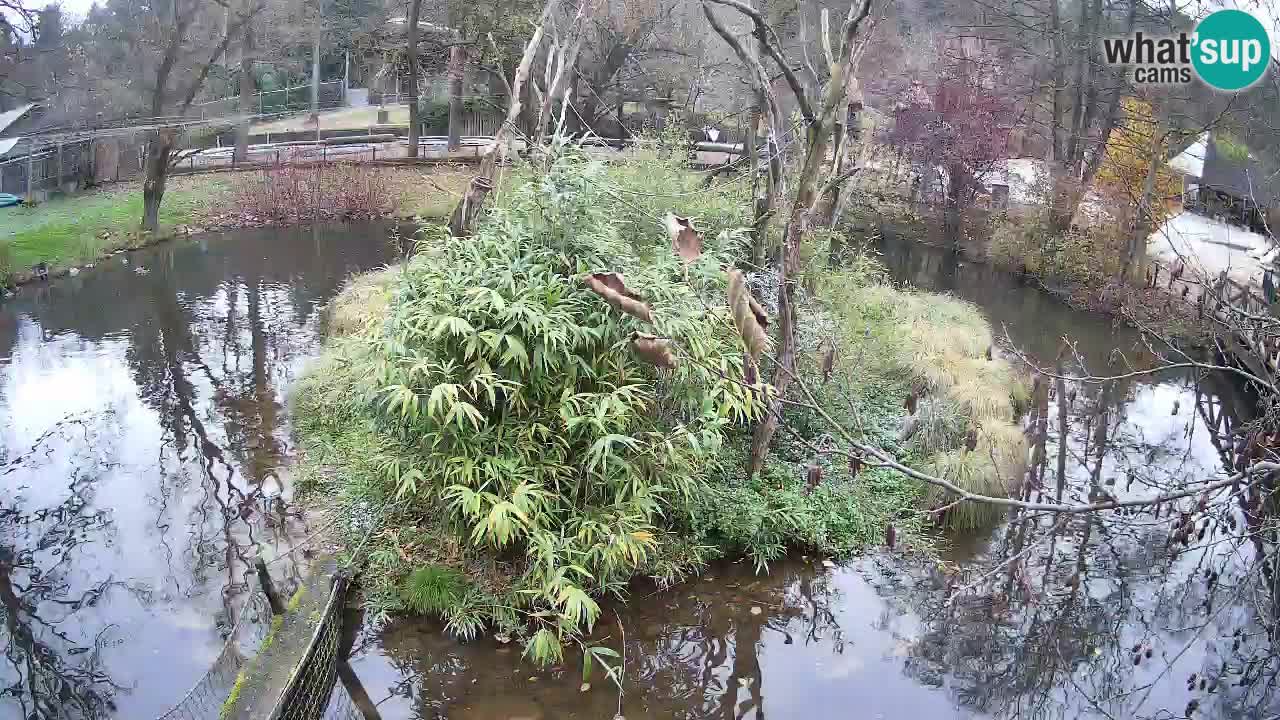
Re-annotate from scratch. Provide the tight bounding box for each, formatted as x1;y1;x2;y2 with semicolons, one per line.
291;146;1024;664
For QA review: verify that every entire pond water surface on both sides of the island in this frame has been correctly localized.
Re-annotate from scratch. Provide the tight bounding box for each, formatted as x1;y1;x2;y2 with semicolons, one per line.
0;227;1280;720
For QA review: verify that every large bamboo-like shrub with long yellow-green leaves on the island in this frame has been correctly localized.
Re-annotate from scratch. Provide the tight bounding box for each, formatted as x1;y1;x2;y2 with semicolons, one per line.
353;151;756;661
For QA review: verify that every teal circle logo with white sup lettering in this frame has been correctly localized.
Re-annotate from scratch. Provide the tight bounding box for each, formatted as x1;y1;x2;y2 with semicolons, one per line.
1192;10;1271;92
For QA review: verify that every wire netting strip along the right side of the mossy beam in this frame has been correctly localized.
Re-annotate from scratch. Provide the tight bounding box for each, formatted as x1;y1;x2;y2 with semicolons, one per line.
270;575;361;720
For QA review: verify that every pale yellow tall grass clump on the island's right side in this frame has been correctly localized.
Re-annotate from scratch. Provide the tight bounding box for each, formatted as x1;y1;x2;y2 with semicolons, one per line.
819;253;1028;528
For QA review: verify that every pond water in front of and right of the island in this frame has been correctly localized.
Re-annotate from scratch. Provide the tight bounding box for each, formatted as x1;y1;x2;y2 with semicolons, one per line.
352;243;1280;720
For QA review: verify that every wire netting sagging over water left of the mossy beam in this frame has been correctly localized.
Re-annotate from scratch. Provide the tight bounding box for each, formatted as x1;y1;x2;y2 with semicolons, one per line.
157;583;271;720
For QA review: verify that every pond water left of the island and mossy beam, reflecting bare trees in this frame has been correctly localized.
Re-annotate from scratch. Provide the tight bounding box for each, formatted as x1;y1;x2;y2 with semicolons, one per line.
0;221;390;720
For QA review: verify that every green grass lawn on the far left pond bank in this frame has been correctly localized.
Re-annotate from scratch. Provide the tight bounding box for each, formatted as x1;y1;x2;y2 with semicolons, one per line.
0;176;230;281
